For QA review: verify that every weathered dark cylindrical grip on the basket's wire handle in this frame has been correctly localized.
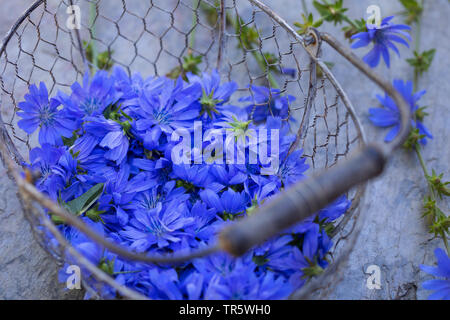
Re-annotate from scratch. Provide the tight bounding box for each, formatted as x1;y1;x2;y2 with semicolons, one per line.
219;144;386;256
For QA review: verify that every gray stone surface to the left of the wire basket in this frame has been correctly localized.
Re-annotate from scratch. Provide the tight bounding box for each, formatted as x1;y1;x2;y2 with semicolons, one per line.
0;0;81;299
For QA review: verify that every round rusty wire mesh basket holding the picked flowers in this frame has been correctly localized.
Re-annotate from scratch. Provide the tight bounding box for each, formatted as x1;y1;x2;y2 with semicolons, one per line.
0;0;407;299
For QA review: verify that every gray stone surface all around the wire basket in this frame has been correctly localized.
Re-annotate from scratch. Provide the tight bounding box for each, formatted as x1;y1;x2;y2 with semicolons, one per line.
0;0;450;299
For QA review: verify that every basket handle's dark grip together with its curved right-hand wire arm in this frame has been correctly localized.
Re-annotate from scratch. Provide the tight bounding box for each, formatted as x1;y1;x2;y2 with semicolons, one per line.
219;29;411;256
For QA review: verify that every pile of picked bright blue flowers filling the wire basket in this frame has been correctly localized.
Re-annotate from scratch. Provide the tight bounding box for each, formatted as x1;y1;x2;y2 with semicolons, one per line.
18;67;350;299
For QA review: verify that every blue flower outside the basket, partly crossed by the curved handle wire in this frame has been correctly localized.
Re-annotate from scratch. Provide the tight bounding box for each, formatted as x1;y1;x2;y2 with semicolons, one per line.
369;80;433;145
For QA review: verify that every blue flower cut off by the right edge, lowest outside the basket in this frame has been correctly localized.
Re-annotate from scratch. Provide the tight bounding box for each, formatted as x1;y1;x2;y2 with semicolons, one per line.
420;248;450;300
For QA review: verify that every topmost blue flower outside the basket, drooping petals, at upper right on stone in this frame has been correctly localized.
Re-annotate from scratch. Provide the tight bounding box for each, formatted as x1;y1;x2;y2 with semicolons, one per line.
352;16;411;68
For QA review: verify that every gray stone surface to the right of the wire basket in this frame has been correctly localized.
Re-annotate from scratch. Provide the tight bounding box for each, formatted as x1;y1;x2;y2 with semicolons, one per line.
296;0;450;299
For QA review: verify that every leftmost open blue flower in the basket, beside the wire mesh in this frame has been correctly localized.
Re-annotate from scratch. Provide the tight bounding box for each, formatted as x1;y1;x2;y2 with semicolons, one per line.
17;82;77;146
